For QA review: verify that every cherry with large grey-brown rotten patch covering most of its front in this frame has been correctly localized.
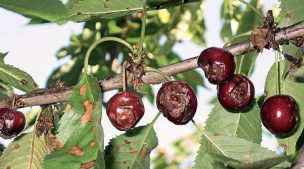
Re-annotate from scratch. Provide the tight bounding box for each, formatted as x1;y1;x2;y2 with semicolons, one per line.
156;81;197;125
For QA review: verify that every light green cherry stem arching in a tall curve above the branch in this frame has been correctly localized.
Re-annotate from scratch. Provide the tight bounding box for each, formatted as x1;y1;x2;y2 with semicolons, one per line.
84;37;133;74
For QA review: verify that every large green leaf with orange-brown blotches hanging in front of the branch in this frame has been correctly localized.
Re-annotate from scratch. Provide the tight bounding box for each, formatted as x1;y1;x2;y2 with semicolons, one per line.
43;75;104;169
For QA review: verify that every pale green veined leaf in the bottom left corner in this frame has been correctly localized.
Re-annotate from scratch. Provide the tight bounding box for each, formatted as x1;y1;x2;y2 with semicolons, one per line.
0;132;48;169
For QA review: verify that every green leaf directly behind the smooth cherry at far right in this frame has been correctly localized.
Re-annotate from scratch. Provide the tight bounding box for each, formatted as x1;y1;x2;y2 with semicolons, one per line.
265;61;304;155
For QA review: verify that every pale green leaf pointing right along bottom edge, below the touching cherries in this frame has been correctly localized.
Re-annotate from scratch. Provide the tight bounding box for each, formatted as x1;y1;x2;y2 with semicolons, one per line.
194;131;288;169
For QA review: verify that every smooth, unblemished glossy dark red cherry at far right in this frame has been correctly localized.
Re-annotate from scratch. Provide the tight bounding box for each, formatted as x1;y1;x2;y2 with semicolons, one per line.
261;95;299;137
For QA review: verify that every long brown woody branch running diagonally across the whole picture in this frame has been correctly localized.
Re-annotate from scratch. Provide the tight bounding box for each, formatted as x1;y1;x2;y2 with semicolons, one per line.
0;21;304;108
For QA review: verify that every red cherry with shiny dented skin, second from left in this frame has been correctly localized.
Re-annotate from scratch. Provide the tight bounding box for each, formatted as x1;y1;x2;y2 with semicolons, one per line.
106;91;145;131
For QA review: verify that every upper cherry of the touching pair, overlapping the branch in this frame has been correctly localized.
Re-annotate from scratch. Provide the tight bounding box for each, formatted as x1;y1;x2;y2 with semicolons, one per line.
197;47;235;84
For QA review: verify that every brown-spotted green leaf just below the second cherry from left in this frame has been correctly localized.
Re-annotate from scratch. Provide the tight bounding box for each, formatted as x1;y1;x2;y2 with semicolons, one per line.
106;123;158;169
